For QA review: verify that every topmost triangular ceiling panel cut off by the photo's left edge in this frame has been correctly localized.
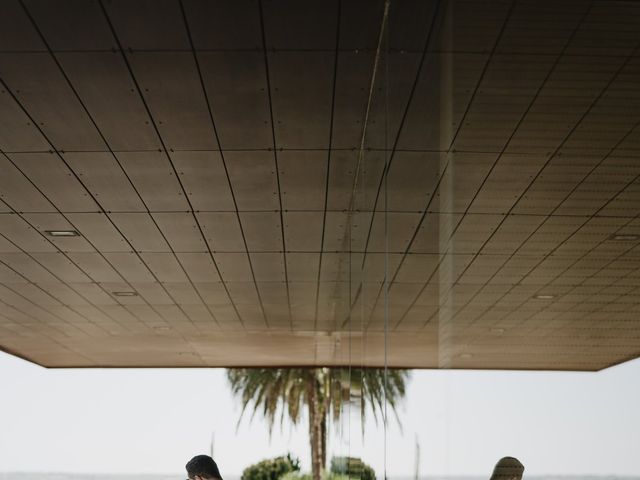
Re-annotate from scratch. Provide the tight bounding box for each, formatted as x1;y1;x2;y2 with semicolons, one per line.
0;93;51;152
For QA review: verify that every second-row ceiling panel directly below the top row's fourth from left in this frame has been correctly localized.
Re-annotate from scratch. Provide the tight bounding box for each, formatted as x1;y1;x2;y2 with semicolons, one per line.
198;51;273;150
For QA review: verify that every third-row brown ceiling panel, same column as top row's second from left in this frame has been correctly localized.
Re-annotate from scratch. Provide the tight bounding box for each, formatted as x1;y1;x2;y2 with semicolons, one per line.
116;152;189;212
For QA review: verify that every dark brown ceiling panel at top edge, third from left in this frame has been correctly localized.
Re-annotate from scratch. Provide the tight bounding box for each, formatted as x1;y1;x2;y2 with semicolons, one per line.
105;0;189;50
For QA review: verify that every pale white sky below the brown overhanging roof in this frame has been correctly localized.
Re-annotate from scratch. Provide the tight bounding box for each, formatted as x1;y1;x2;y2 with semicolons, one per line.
0;352;640;477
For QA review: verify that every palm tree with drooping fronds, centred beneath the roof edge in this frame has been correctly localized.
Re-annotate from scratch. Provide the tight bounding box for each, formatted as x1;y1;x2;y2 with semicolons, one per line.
227;368;409;480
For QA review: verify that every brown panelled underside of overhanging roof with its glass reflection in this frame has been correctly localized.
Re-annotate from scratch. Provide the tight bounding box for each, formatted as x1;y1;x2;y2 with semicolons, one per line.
0;0;640;370
